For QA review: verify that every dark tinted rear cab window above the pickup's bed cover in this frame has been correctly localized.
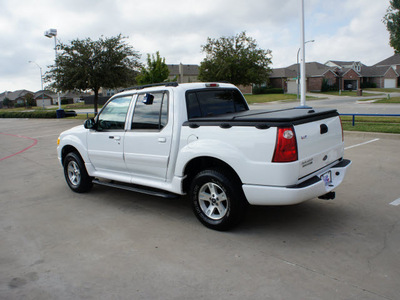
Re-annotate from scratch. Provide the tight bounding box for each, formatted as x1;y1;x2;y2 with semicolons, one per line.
186;89;248;119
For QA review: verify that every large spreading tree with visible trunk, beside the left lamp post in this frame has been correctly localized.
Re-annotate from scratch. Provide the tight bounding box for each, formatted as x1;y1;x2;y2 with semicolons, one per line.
46;34;141;113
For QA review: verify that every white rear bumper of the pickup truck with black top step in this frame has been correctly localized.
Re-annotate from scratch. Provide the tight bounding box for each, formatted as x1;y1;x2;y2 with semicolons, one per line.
243;159;351;205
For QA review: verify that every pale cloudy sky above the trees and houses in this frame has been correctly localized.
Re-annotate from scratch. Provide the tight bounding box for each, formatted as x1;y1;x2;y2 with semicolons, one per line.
0;0;394;93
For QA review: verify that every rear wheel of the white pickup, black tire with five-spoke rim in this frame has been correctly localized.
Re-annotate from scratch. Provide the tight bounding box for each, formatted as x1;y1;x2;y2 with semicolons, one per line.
190;170;248;231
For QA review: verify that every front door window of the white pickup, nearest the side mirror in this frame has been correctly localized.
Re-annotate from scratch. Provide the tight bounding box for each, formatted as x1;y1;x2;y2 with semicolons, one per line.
97;95;132;130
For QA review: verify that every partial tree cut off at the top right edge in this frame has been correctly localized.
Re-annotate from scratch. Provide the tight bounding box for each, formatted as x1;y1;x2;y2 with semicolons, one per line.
383;0;400;53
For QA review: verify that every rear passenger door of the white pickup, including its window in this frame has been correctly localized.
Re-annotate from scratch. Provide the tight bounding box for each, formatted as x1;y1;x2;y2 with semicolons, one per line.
124;91;173;181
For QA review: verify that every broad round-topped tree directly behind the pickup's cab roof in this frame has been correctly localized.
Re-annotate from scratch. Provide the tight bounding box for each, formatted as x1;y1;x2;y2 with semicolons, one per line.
199;32;271;85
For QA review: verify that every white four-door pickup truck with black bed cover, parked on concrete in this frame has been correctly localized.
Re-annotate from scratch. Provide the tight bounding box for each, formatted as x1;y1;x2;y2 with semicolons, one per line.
57;83;351;230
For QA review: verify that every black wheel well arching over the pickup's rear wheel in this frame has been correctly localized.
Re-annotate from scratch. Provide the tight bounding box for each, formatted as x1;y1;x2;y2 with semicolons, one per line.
182;157;242;192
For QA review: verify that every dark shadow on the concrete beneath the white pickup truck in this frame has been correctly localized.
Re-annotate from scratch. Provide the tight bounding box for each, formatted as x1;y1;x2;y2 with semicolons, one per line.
87;186;355;235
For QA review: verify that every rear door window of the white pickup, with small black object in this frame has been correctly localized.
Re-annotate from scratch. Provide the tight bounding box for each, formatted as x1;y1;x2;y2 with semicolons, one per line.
131;92;168;130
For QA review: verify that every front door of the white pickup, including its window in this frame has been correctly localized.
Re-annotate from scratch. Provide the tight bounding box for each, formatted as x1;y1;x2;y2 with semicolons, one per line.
87;95;132;173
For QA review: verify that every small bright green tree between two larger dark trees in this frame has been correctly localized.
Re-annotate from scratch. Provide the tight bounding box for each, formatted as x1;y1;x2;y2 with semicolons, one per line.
136;51;169;84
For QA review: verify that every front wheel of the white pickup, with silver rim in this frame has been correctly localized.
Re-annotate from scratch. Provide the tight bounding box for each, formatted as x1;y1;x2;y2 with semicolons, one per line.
64;152;93;193
